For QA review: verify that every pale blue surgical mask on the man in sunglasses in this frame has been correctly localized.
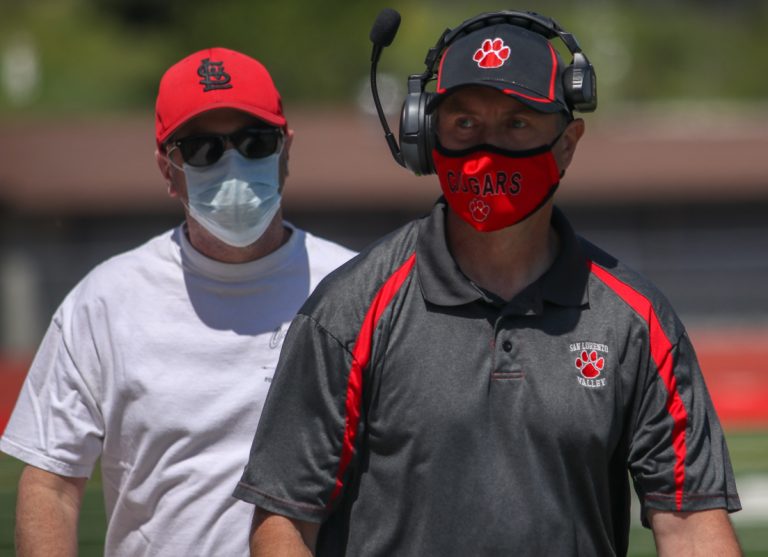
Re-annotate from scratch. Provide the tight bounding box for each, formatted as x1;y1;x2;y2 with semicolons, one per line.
183;149;281;248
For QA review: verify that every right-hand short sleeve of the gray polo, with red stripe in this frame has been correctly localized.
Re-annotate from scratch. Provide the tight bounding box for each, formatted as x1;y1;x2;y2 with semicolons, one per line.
629;334;741;526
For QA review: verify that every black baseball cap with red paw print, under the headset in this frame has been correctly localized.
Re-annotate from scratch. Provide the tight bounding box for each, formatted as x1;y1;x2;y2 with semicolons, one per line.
427;23;570;113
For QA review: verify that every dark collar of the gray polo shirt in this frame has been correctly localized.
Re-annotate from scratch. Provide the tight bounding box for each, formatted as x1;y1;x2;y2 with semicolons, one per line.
416;197;589;307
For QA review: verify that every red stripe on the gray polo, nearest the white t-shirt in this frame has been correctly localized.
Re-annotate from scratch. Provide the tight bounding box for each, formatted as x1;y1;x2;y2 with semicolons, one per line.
328;253;416;506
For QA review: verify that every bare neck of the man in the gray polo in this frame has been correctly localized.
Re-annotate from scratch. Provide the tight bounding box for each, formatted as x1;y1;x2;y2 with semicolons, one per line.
446;203;560;300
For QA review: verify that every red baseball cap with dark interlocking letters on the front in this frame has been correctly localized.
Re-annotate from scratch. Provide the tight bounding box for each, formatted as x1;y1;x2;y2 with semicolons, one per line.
155;47;286;146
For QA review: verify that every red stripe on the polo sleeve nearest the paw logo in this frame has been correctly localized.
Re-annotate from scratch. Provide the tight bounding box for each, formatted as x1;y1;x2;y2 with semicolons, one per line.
589;261;688;511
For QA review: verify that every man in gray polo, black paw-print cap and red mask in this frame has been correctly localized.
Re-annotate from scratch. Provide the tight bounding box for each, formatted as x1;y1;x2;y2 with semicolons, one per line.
235;10;740;557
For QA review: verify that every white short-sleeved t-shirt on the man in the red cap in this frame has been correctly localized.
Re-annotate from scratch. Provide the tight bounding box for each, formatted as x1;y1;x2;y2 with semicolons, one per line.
0;227;354;557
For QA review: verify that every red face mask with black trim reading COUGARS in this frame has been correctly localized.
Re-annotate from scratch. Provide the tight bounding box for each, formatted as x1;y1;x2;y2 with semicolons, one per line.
432;139;560;232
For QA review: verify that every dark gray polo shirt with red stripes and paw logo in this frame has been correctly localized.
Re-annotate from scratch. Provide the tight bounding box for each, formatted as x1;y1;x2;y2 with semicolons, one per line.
235;200;740;557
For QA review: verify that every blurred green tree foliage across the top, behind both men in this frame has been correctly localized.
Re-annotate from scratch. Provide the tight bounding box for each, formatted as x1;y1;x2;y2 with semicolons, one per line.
0;0;768;117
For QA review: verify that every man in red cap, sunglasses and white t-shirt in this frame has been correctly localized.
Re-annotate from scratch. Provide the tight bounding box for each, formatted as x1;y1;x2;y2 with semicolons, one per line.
0;48;353;557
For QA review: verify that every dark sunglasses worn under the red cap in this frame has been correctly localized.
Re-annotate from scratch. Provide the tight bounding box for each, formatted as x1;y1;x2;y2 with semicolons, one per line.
169;127;283;166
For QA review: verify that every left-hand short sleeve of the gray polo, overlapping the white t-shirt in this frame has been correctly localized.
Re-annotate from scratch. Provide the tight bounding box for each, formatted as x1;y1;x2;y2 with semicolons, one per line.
234;314;359;522
